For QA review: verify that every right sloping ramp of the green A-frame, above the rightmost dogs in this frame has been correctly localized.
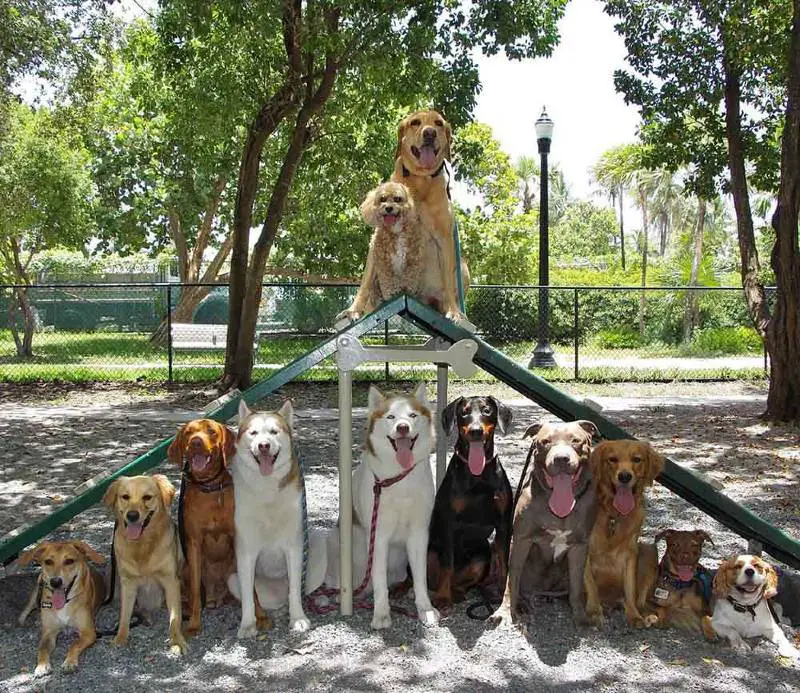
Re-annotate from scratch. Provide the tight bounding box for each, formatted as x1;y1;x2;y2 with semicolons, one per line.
403;297;800;569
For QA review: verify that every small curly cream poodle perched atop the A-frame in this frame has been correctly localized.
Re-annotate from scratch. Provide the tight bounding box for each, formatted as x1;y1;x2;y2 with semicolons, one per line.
336;182;433;322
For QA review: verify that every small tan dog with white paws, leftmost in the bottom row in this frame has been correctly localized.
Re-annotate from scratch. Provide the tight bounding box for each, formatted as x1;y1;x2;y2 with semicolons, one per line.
19;541;106;676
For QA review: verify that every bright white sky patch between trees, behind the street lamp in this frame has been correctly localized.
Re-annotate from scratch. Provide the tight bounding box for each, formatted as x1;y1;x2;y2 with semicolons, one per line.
457;0;639;203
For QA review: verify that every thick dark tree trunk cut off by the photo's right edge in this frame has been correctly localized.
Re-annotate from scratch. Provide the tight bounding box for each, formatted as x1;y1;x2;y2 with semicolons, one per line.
764;0;800;422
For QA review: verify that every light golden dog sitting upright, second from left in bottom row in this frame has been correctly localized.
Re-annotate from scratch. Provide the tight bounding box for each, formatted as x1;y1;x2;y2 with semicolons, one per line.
103;474;187;654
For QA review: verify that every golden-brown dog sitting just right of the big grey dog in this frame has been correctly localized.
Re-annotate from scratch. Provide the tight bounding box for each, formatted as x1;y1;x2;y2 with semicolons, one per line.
584;440;664;628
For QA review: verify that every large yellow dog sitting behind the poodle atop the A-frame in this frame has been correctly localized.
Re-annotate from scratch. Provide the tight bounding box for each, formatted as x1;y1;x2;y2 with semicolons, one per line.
392;111;469;320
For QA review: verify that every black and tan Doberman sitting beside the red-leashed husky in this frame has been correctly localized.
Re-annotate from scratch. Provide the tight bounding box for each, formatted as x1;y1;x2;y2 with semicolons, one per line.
428;397;512;609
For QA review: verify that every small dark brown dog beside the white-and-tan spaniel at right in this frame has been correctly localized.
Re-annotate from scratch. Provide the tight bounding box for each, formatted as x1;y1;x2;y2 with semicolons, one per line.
645;529;717;640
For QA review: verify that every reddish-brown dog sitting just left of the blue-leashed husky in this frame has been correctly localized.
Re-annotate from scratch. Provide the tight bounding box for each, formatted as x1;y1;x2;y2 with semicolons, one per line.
167;419;236;635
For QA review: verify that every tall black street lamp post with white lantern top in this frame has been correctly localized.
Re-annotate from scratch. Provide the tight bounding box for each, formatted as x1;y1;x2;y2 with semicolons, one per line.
528;108;556;368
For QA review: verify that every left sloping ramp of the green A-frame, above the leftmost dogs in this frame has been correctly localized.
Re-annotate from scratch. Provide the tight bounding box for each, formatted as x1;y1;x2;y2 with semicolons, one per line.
0;296;405;565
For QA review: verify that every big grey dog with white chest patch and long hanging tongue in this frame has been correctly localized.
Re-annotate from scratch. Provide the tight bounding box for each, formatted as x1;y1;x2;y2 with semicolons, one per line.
491;421;598;626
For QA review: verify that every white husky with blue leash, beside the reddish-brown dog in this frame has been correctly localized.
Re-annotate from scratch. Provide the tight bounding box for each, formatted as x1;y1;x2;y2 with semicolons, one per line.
228;401;327;638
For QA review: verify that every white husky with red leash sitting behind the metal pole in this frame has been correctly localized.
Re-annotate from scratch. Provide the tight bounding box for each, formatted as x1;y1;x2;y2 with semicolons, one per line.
325;383;439;628
